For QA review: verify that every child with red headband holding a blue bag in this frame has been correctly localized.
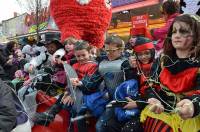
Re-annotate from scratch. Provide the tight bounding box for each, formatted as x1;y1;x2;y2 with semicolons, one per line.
107;37;158;132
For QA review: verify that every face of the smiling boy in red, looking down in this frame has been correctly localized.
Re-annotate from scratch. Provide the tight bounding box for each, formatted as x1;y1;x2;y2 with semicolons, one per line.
74;49;90;63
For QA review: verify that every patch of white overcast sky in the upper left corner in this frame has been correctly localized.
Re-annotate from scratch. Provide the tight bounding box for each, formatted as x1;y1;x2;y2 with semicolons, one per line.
0;0;22;22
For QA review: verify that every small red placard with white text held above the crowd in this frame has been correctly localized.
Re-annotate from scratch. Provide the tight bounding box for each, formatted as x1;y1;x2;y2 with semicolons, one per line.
131;15;148;28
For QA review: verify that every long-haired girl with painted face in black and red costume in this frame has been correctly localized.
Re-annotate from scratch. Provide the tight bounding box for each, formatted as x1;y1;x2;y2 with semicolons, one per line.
141;14;200;132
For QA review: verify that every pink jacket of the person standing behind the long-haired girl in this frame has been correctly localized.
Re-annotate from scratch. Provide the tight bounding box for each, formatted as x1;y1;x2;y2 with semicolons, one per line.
152;13;179;51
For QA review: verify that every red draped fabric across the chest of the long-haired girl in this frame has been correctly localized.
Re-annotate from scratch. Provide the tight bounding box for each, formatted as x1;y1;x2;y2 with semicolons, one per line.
160;68;198;93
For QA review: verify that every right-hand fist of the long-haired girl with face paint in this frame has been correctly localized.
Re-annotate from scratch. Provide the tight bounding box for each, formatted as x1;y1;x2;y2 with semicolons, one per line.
176;99;194;119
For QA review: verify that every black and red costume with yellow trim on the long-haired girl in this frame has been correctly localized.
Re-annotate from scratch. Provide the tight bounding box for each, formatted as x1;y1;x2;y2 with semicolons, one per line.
143;58;200;132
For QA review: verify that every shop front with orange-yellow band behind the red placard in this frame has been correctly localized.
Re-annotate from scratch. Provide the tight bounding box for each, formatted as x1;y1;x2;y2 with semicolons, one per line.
108;0;165;40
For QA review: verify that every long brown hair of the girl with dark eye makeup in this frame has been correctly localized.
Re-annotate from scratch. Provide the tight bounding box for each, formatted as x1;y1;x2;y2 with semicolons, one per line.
164;14;200;58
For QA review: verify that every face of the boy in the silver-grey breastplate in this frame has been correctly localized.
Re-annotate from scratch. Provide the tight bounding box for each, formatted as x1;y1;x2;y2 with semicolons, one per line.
105;44;122;60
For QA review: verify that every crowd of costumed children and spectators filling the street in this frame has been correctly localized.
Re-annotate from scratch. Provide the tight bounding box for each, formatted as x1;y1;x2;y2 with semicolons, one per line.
0;0;200;132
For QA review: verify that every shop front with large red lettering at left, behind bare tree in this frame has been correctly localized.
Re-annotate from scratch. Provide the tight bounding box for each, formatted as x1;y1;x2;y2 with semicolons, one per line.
2;8;60;43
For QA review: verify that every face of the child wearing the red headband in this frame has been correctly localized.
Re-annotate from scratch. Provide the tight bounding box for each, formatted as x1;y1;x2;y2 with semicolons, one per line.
136;50;151;64
